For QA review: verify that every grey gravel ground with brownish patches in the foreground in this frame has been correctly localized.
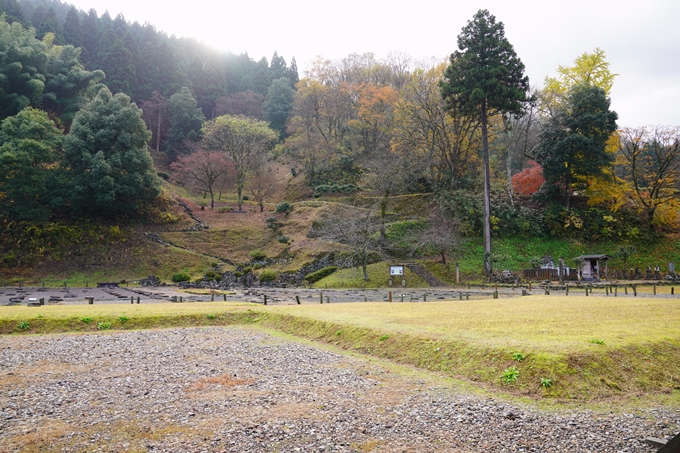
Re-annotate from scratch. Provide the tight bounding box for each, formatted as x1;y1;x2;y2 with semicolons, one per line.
0;327;680;453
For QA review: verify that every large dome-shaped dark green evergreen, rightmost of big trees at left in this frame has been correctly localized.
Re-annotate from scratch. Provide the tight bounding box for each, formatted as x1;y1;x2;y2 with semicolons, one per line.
64;87;161;217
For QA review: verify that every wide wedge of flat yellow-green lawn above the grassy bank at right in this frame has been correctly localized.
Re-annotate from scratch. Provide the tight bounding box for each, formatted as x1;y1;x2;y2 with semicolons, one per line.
269;296;680;352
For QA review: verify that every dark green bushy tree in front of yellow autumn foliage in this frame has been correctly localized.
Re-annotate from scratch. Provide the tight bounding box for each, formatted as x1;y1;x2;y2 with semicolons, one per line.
534;84;618;209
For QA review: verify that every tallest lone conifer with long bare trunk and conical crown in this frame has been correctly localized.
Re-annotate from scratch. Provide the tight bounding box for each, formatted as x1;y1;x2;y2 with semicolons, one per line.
441;10;529;276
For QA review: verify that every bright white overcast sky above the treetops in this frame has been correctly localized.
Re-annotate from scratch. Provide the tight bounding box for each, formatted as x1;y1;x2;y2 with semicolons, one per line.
65;0;680;126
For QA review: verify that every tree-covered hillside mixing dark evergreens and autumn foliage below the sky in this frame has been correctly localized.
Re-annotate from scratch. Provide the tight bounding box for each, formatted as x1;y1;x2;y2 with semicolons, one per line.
0;0;680;282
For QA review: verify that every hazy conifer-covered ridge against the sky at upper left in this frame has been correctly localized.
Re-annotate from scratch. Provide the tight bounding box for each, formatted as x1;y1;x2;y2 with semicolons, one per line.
0;0;298;118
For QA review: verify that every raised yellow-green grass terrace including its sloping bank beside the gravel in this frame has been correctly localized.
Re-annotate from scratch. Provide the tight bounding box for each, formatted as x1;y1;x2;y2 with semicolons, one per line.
0;296;680;403
